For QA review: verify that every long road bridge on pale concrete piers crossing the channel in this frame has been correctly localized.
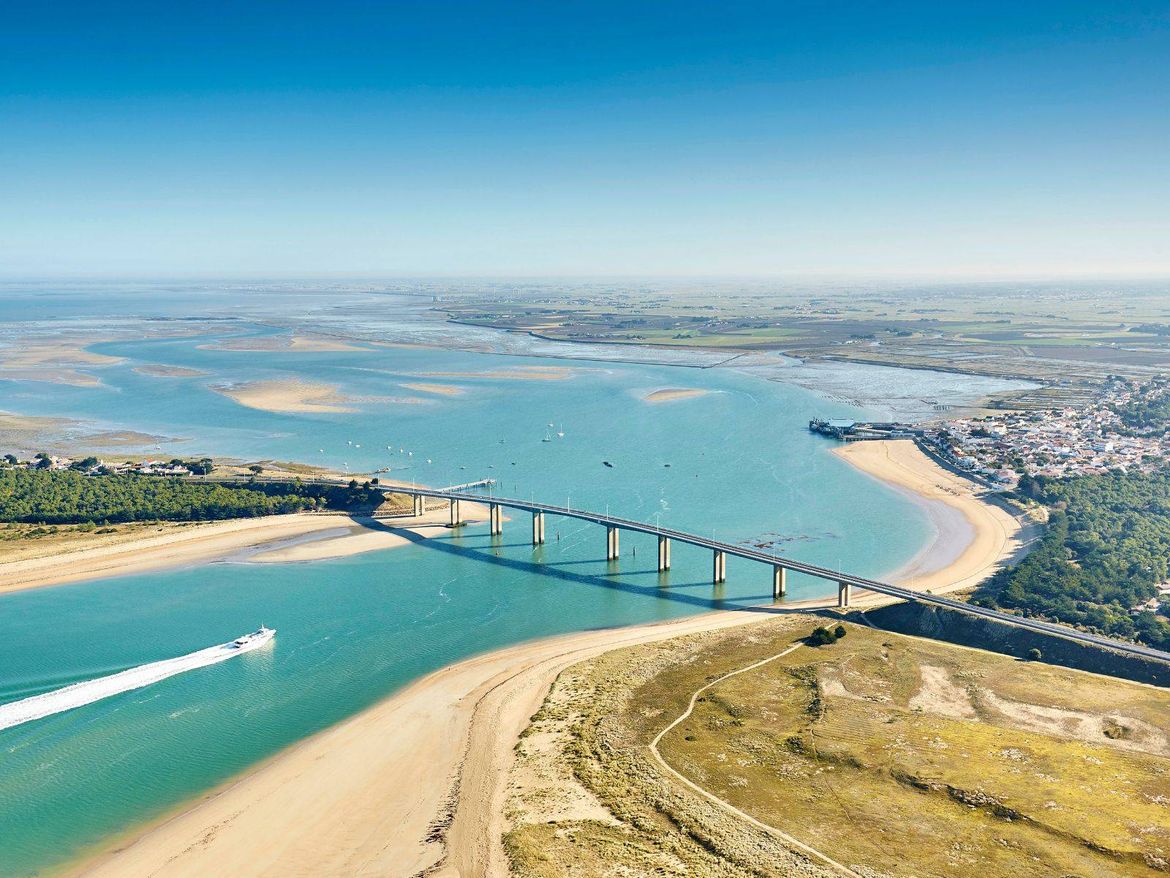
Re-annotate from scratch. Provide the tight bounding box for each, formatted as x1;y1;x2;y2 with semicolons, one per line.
377;485;1170;661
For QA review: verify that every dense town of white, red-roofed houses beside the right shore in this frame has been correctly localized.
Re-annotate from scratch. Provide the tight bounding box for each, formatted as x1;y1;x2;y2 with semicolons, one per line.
922;382;1170;488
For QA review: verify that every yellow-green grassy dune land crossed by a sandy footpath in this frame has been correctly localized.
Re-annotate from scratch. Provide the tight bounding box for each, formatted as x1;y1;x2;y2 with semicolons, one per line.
507;619;1170;878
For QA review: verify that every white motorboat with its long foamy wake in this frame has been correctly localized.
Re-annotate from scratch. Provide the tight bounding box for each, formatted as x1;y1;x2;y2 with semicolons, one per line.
0;627;276;730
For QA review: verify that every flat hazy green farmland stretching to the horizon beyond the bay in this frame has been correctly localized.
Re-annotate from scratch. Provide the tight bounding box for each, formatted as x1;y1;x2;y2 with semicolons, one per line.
441;283;1170;398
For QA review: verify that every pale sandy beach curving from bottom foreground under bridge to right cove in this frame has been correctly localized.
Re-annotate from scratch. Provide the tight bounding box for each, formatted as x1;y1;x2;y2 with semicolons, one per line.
59;443;1027;878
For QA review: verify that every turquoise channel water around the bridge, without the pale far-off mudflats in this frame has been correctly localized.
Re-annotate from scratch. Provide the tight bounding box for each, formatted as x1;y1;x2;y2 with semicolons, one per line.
0;320;930;876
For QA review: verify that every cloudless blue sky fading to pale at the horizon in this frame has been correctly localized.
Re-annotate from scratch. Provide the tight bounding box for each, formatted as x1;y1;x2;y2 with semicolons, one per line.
0;0;1170;276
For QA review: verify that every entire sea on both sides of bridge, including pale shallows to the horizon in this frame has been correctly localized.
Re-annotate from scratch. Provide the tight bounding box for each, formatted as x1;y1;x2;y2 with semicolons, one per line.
0;282;1034;876
